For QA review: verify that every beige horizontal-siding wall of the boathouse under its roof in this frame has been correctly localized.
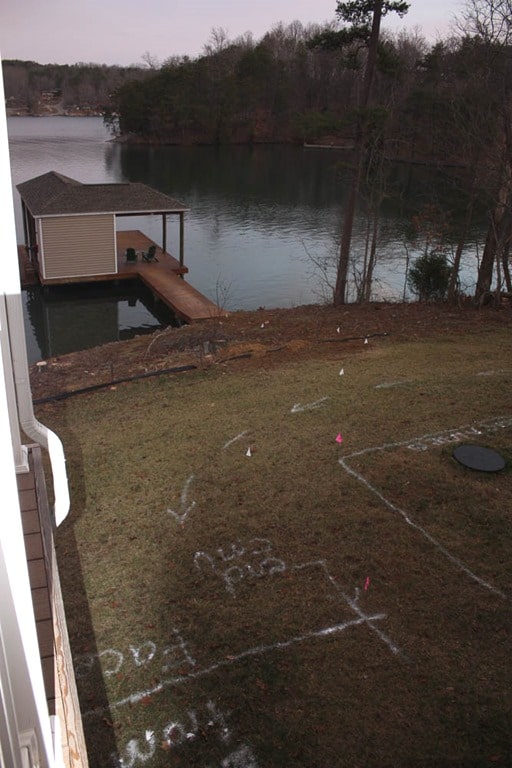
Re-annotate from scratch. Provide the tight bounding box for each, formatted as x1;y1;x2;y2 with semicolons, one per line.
40;214;117;280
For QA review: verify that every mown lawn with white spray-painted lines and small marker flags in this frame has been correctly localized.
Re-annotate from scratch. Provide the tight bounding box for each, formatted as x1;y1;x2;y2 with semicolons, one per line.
38;330;512;768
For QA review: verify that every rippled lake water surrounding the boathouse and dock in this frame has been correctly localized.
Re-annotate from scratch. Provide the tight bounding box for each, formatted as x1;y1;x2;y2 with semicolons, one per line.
8;117;482;362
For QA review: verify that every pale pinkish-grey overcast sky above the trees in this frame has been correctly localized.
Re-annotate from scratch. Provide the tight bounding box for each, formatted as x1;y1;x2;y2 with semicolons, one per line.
0;0;465;66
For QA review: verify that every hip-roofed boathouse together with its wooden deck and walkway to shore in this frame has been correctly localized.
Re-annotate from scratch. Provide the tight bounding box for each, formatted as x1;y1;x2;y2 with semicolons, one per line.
17;171;222;322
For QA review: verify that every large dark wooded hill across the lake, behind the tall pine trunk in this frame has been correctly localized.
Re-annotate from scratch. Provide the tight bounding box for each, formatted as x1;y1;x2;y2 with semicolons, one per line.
106;21;429;154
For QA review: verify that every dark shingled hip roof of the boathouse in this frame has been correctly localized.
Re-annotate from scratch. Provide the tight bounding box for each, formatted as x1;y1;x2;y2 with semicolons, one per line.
17;171;188;216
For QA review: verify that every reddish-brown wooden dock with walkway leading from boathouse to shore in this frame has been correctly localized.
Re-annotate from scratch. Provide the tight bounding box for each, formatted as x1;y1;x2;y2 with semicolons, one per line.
18;230;226;323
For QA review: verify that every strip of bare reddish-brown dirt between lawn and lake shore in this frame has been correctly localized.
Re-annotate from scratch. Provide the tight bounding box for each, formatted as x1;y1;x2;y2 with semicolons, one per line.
31;303;512;400
